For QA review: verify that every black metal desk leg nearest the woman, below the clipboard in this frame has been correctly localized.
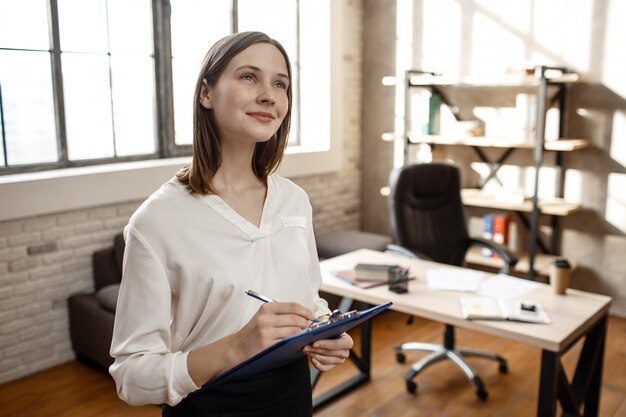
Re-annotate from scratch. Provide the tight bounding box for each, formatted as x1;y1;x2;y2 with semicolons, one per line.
311;298;372;408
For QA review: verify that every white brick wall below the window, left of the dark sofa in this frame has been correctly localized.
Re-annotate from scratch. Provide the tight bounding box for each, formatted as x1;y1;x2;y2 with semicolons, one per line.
0;202;139;383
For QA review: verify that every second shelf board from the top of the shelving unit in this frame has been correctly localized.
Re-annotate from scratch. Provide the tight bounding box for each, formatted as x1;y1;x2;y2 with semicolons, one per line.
402;133;589;152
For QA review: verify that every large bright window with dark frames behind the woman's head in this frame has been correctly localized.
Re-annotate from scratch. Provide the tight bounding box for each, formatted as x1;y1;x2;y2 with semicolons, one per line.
0;0;330;174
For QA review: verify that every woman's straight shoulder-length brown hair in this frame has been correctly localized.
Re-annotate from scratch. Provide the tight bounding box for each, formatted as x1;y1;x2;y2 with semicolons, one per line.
176;32;292;195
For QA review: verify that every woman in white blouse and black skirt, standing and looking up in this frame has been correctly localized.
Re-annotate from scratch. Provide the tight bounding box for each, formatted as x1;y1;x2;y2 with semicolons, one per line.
110;32;352;417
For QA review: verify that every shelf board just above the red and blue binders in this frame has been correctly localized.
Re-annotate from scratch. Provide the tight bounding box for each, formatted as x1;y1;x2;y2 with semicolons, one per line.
461;188;582;216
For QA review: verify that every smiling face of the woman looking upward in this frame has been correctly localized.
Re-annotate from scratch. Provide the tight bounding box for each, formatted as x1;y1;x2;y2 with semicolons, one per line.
200;43;290;143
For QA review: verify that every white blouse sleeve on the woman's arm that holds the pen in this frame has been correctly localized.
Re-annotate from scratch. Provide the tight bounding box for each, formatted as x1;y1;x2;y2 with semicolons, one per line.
110;226;198;405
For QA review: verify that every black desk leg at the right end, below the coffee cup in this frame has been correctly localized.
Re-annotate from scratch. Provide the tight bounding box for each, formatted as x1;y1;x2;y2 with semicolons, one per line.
537;316;607;417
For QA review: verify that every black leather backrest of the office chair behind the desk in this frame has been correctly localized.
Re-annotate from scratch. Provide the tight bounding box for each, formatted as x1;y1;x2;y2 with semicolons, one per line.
388;163;469;265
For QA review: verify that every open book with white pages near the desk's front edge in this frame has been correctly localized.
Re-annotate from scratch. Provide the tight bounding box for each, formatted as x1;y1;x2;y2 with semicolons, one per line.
459;296;551;324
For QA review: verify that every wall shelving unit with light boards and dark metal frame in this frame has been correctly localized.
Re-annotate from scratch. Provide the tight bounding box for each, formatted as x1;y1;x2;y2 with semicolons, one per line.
383;67;589;279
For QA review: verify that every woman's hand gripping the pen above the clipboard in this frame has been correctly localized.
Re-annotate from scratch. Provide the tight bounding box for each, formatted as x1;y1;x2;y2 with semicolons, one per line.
233;302;314;361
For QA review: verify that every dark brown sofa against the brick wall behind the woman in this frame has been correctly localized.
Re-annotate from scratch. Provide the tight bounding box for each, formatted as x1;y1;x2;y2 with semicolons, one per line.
68;233;124;368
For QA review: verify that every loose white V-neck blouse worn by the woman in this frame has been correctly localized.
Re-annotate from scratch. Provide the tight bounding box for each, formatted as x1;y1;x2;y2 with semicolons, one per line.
109;175;329;405
